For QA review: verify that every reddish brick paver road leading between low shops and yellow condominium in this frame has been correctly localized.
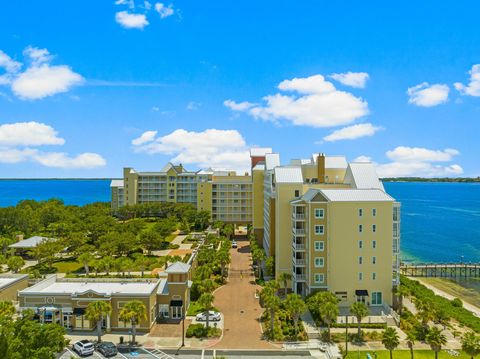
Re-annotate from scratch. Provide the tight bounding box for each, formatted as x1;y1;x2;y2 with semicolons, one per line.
214;240;274;349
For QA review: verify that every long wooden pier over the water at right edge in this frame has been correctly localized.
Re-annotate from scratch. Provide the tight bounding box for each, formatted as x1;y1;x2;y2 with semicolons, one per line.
400;263;480;278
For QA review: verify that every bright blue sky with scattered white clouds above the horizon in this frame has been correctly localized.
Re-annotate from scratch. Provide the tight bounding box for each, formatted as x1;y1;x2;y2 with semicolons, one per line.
0;0;480;177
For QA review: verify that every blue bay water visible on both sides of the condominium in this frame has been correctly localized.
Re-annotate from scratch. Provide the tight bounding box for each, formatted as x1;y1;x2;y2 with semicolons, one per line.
0;180;480;262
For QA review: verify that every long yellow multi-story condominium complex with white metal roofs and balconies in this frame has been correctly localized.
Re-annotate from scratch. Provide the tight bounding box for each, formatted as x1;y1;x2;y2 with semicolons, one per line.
112;148;400;306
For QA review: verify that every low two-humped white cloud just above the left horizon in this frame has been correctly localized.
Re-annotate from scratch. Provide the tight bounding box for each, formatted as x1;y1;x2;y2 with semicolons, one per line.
33;152;107;169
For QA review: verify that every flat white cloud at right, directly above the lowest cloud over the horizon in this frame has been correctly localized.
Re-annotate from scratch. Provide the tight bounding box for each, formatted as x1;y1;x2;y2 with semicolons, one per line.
386;146;459;162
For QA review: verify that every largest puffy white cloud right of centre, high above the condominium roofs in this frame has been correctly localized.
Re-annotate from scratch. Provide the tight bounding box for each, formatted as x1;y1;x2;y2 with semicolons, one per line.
224;75;368;127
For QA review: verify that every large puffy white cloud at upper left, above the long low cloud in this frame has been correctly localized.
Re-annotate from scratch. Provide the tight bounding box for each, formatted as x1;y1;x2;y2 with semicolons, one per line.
12;64;84;100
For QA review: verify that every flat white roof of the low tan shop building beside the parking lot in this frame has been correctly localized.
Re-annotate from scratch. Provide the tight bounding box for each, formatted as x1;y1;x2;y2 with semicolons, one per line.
20;279;158;296
